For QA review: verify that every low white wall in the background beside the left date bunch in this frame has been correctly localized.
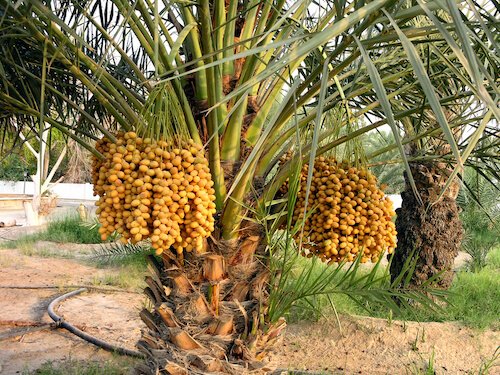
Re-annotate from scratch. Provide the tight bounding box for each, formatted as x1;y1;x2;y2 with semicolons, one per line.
0;181;97;201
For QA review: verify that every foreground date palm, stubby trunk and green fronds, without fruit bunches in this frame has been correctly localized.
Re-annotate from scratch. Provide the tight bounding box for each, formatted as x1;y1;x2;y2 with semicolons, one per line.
0;0;498;374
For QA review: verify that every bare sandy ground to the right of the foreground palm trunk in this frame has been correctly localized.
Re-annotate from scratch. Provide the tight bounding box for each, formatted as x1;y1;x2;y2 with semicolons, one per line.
271;316;500;375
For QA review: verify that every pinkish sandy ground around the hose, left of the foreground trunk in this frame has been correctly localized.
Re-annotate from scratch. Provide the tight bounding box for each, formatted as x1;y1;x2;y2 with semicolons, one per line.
0;239;144;375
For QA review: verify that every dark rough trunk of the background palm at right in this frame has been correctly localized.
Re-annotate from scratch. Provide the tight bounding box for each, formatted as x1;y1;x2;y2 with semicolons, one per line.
390;162;463;288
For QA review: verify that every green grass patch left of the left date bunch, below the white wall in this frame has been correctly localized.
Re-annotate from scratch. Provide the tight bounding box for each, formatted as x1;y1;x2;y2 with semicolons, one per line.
5;216;102;248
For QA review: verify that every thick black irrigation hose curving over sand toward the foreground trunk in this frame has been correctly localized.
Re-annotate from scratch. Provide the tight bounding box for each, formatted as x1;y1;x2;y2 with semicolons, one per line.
47;288;144;358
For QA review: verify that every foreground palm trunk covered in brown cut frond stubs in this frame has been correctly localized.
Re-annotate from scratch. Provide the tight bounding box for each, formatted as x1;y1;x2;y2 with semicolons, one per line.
139;224;285;374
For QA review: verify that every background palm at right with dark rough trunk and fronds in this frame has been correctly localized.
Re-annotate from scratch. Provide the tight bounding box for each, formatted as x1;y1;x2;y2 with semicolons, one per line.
356;2;498;288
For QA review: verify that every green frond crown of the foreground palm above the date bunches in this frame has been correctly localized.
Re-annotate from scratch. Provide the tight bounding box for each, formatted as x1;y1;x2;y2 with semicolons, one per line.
0;0;500;236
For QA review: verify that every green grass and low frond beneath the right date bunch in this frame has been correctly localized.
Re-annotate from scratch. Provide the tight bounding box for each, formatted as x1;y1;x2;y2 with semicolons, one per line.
269;238;434;322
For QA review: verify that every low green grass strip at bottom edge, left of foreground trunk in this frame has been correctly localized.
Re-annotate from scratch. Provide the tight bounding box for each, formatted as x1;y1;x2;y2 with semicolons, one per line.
23;358;136;375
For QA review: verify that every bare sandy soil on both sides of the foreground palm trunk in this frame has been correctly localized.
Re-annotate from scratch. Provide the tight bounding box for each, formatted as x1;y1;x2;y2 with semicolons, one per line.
0;231;500;375
